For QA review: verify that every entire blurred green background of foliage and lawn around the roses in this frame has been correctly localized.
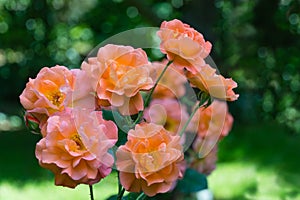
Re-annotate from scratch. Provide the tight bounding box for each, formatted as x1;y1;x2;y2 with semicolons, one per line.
0;0;300;200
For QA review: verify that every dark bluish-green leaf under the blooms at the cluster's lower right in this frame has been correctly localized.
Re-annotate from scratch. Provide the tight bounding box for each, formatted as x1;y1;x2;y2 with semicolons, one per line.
176;169;207;194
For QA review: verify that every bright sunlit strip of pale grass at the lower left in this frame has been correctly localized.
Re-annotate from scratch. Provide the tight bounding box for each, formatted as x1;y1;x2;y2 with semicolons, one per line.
0;174;117;200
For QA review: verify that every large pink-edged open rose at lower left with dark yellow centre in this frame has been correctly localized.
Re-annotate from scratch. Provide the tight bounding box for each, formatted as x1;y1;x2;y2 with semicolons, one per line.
35;109;117;188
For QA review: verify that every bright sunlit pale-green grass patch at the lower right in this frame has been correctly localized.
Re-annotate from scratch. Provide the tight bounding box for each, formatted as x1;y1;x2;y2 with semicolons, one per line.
209;162;300;200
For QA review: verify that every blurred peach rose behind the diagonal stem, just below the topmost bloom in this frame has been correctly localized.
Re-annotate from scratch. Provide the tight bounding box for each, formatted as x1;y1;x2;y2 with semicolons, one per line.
152;60;187;99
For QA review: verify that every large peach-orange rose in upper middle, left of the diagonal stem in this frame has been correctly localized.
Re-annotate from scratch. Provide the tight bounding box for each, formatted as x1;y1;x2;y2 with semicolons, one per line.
81;44;153;115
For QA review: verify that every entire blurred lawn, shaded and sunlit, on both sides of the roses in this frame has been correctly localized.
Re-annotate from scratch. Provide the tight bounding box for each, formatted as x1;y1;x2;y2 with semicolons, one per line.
0;121;300;200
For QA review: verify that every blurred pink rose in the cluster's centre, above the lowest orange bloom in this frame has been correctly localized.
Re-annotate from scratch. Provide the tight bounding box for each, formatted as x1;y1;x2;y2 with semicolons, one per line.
144;98;189;135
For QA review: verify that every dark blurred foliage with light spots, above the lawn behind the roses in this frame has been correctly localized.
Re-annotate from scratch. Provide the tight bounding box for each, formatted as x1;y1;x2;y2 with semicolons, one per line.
0;0;300;132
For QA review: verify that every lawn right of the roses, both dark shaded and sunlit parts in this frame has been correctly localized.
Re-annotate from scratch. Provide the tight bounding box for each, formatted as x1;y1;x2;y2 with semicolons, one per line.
209;121;300;200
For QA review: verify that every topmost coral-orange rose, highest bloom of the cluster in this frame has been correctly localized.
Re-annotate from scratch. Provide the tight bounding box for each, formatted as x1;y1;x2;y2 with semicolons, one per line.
157;19;212;73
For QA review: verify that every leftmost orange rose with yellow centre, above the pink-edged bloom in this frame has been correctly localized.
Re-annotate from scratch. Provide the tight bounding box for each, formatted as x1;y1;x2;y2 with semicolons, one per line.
20;65;74;116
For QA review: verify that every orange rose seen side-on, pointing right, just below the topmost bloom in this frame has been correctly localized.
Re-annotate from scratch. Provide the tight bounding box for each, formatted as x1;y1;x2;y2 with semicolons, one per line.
186;64;239;101
